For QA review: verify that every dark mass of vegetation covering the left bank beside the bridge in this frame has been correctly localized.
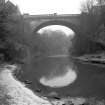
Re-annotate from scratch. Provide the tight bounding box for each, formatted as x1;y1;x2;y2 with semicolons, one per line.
0;0;31;64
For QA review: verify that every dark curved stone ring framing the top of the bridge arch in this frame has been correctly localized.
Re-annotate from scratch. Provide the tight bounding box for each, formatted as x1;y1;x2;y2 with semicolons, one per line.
34;20;81;35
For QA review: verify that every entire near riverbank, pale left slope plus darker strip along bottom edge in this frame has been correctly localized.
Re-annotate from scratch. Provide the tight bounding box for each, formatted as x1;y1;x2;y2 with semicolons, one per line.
0;65;105;105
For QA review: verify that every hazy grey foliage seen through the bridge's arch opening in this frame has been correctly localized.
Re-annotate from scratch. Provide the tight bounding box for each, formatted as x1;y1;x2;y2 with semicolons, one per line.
34;30;71;56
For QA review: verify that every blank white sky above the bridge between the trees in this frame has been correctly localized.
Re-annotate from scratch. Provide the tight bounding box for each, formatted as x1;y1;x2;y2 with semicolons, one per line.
10;0;84;15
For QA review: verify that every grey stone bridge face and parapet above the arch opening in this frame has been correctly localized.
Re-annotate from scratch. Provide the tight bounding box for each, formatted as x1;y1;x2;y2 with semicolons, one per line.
24;14;81;34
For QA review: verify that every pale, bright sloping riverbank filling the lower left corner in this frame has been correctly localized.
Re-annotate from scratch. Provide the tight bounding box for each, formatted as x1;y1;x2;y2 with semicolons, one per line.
0;65;51;105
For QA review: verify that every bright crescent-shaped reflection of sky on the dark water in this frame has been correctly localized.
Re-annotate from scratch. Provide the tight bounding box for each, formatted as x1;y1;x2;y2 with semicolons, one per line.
40;66;77;88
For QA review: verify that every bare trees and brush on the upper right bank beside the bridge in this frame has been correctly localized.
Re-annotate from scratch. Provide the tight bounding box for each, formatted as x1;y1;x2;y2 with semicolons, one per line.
81;0;105;45
